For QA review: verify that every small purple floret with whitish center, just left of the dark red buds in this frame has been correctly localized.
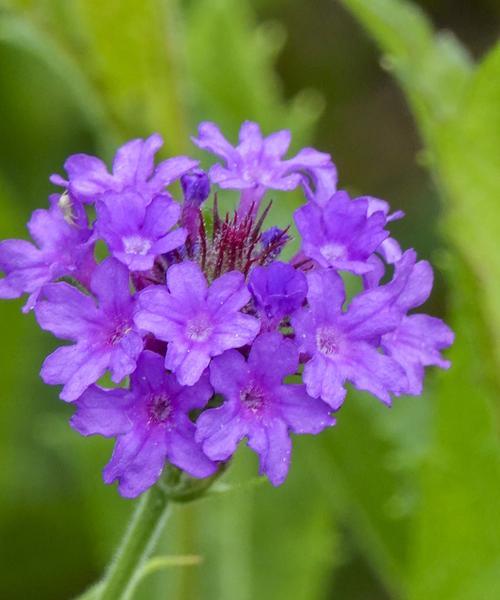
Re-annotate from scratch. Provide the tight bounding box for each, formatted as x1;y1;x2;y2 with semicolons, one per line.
96;191;186;271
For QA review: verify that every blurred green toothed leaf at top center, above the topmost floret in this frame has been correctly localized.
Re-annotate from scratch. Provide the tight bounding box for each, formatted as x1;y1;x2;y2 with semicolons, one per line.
186;0;322;144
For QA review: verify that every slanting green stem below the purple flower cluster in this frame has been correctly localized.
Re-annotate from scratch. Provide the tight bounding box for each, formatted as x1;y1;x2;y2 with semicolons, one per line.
97;486;169;600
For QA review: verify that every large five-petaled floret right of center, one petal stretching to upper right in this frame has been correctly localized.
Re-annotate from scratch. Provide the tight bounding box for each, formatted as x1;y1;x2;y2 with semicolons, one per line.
292;250;422;410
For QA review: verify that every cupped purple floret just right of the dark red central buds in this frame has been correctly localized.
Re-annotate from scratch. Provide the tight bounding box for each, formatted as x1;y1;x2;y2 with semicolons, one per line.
294;191;389;275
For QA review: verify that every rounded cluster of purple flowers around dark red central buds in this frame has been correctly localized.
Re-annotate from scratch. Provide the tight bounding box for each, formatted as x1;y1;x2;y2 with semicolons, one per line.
0;122;453;497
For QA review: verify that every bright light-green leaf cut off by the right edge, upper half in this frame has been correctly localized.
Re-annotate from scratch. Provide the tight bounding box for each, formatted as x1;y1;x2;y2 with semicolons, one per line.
436;44;500;365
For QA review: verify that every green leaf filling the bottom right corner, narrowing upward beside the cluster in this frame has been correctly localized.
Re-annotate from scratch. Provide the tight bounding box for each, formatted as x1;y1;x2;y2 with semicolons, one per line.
410;259;500;600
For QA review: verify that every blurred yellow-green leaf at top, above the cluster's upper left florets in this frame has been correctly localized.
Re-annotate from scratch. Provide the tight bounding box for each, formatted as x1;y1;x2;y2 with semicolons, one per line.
64;0;188;152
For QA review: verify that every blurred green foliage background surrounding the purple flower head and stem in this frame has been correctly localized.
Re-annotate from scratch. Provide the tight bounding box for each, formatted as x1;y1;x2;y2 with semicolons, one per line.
0;0;500;600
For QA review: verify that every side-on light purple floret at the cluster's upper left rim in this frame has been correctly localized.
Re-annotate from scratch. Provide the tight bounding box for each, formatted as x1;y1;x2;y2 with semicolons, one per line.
50;133;197;203
